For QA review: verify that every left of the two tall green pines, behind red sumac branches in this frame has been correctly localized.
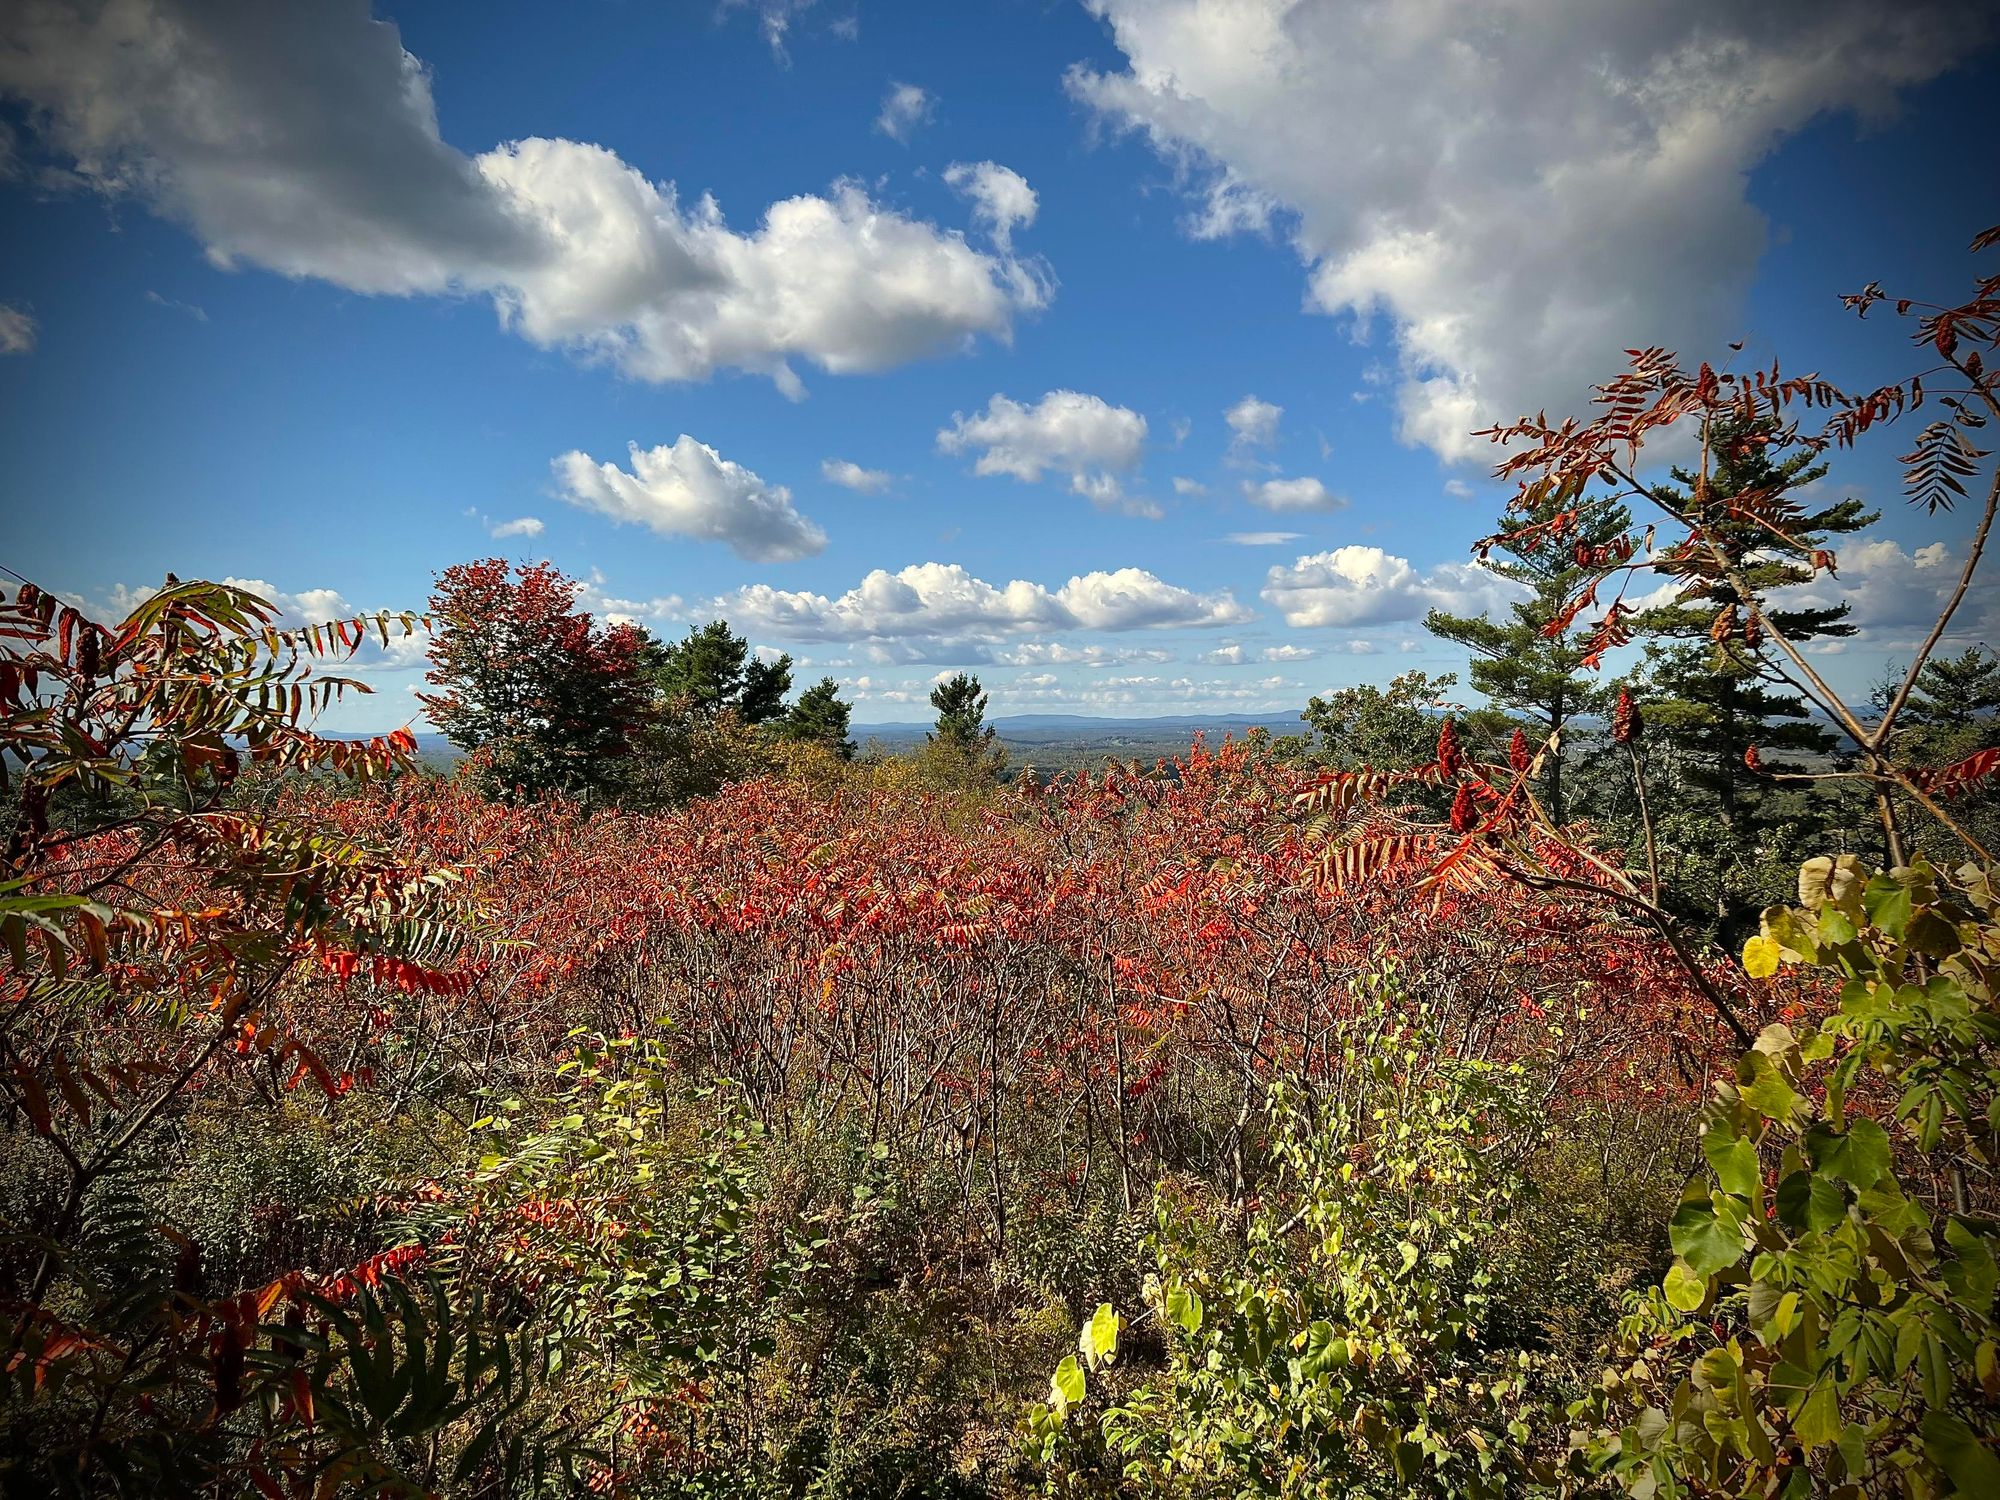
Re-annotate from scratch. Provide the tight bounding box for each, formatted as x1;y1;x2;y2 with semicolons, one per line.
1424;498;1632;826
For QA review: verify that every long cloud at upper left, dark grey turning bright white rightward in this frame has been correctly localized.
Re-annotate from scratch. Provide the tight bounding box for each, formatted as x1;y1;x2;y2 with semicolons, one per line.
0;0;1050;394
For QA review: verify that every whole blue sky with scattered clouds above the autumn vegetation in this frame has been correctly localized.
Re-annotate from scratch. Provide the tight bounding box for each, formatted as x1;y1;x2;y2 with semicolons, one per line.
0;0;2000;728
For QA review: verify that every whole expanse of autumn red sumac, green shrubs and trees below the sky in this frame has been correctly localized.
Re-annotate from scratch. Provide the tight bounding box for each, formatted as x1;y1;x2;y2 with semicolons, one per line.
0;228;2000;1500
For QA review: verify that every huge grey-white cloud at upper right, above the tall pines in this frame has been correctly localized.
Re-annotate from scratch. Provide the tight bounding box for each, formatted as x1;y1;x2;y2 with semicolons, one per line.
1070;0;1994;458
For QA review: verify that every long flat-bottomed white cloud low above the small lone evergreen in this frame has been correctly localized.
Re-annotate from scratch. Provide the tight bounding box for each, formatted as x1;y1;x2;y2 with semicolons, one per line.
712;562;1250;640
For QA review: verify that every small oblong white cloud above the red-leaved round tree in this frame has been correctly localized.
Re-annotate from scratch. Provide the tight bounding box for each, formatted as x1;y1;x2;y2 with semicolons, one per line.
552;432;826;562
